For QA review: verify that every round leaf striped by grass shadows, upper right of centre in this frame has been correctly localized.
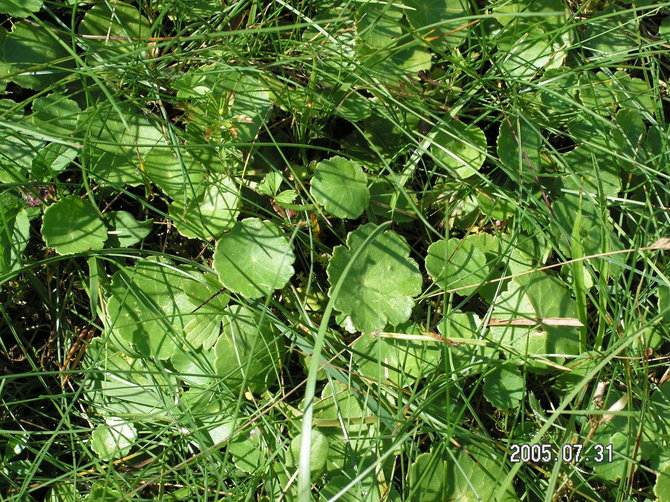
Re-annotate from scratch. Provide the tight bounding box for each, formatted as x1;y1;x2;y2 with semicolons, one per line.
430;119;486;178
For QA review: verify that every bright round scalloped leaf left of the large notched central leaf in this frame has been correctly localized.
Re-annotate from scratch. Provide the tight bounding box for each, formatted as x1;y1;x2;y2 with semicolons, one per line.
214;218;295;298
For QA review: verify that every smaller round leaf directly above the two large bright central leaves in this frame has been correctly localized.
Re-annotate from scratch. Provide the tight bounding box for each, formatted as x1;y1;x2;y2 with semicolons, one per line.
310;157;370;218
